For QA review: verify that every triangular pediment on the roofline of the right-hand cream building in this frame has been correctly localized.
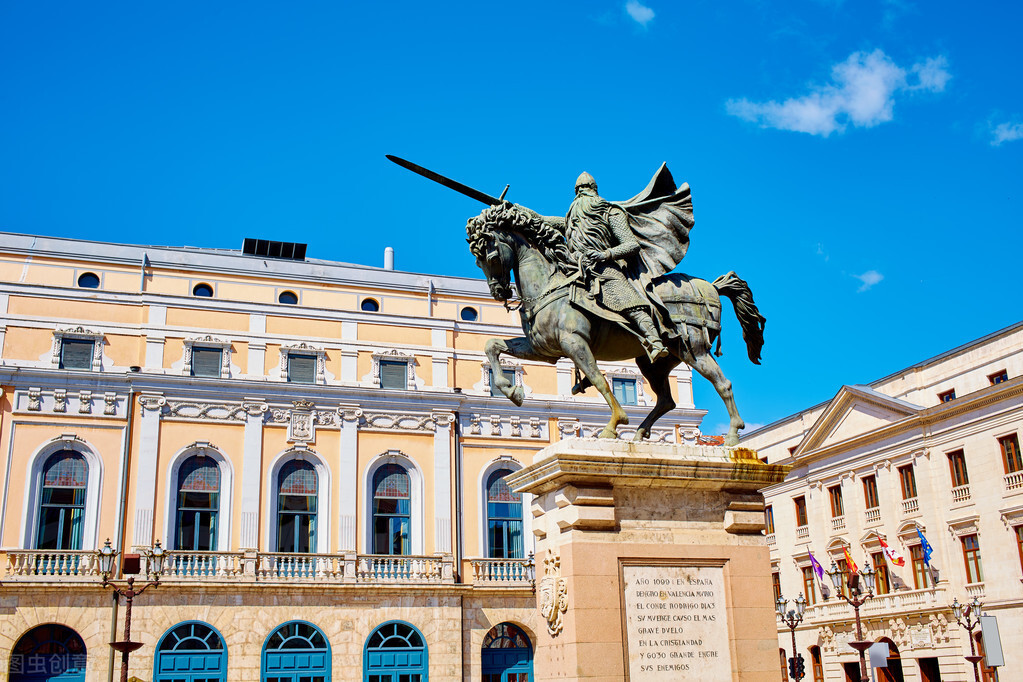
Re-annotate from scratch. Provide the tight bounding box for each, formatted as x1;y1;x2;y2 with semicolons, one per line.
794;385;924;457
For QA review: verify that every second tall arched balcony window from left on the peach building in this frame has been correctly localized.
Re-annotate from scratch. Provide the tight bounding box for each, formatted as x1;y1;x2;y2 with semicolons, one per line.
174;455;220;552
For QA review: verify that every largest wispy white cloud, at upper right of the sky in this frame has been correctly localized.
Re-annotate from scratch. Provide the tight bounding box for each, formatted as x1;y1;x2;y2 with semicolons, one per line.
725;50;951;137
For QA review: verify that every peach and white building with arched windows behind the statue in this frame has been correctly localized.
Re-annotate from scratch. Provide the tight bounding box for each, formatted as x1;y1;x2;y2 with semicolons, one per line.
0;233;704;682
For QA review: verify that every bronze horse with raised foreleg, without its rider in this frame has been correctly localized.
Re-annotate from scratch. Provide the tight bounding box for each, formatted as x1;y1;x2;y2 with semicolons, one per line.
465;202;765;445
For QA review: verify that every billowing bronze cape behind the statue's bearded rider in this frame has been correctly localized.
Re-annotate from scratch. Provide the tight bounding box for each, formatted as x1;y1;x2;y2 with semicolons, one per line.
613;164;695;283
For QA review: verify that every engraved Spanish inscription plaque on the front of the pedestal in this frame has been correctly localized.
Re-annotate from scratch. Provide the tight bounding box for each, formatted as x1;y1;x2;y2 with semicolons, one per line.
622;564;732;682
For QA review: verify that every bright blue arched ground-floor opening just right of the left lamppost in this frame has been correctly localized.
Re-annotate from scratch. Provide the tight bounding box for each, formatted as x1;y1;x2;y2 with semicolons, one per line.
153;622;227;682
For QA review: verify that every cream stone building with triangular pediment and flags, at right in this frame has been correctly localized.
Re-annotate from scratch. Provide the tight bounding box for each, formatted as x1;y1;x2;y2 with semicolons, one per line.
742;323;1023;682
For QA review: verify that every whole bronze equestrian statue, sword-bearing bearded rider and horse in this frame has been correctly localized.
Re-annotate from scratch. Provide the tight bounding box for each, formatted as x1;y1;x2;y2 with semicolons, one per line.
388;156;766;445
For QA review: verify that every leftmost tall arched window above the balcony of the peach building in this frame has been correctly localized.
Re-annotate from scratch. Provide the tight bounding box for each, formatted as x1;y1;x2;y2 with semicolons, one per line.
36;450;89;549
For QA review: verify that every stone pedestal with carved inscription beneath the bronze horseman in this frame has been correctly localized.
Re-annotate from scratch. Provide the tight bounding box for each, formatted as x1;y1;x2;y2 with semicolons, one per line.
507;439;787;682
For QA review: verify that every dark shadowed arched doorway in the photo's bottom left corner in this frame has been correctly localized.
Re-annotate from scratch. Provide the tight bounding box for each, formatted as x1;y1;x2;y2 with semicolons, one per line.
8;623;86;682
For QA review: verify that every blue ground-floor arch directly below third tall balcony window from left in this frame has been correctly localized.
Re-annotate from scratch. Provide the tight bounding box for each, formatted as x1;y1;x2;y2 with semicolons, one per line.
260;621;330;682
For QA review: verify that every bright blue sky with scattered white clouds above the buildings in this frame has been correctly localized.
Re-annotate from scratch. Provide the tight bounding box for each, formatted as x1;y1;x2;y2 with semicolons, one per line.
0;0;1023;431
